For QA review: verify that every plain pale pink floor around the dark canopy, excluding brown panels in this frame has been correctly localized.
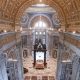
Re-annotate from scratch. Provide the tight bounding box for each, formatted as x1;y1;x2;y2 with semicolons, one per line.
23;56;57;80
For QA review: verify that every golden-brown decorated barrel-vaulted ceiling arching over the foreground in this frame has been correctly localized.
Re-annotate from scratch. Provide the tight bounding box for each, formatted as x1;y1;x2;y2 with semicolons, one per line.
0;0;80;28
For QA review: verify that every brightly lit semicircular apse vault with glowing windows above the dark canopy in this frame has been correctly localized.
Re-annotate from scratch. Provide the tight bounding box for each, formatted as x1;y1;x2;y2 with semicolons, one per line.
29;14;52;29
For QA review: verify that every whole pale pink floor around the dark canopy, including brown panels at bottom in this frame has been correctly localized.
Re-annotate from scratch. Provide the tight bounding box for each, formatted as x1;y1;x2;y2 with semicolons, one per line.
23;56;57;80
